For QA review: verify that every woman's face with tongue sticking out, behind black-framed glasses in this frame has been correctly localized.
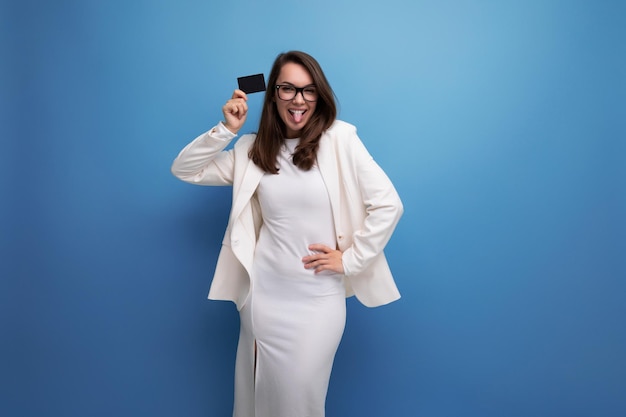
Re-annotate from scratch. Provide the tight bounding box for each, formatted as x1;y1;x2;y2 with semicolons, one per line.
274;62;316;138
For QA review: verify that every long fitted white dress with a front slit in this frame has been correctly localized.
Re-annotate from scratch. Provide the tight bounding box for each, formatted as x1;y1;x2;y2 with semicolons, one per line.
233;139;346;417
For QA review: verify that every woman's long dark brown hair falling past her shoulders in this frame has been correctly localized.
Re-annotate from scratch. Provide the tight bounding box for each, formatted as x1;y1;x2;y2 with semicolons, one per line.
248;51;337;174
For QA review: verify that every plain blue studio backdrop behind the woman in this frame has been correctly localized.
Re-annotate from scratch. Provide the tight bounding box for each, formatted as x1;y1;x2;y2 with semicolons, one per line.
0;0;626;417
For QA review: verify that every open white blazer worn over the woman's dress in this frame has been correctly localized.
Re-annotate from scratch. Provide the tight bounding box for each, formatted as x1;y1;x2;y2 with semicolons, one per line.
172;120;403;309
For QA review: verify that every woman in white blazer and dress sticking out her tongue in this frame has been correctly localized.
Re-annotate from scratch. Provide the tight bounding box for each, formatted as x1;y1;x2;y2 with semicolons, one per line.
172;51;403;417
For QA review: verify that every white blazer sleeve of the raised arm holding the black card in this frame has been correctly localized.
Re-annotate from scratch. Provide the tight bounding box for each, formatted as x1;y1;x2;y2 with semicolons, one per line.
171;123;236;185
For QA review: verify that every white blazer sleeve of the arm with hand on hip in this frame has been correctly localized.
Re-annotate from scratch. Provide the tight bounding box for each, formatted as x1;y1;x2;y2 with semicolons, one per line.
342;126;404;276
